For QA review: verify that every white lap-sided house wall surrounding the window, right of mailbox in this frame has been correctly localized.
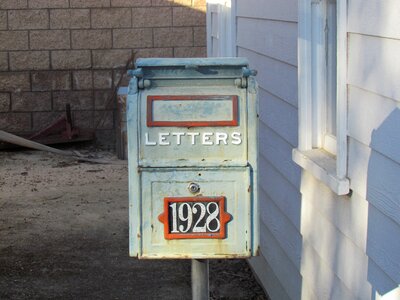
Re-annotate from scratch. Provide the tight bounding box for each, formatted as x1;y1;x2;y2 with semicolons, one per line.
236;0;400;299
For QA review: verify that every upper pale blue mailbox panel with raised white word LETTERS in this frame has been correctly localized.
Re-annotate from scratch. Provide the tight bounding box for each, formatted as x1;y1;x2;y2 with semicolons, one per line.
138;86;248;167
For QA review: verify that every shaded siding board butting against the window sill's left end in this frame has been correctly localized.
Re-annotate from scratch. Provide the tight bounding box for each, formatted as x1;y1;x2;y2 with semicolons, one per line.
259;122;301;187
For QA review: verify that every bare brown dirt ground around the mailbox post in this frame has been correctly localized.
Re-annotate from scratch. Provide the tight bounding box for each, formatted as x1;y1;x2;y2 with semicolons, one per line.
0;151;267;300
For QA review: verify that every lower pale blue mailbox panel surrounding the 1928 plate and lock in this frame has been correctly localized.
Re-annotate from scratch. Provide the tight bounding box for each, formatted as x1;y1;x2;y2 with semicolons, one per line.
134;167;252;258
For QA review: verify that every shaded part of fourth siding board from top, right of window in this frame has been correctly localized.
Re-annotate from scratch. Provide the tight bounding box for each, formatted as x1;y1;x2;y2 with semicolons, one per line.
367;151;400;226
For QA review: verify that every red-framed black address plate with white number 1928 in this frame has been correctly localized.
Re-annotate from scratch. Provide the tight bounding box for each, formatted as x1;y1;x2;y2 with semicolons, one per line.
158;197;232;240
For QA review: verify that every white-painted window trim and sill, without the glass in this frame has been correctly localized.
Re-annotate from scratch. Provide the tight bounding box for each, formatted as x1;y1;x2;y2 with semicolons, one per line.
292;0;350;195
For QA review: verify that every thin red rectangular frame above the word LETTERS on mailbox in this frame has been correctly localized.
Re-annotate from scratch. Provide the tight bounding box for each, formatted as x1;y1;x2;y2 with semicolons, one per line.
147;95;239;127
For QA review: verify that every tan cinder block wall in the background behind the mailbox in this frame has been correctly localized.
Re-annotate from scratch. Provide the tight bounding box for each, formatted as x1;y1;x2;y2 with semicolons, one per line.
0;0;206;145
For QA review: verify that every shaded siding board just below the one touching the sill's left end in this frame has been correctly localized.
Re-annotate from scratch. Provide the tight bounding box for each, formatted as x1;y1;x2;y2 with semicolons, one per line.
259;157;301;231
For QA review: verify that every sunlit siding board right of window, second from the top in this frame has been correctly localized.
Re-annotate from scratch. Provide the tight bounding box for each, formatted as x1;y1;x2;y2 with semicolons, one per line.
348;34;400;101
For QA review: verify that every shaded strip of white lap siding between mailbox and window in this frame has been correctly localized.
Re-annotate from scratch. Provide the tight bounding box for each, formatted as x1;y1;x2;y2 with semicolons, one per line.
237;0;302;299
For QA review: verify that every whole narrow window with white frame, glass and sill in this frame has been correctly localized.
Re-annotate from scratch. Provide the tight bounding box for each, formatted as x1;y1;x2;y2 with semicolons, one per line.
293;0;349;195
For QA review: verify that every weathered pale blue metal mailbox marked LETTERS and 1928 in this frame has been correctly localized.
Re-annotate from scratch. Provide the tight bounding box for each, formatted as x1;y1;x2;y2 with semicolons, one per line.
127;58;259;259
